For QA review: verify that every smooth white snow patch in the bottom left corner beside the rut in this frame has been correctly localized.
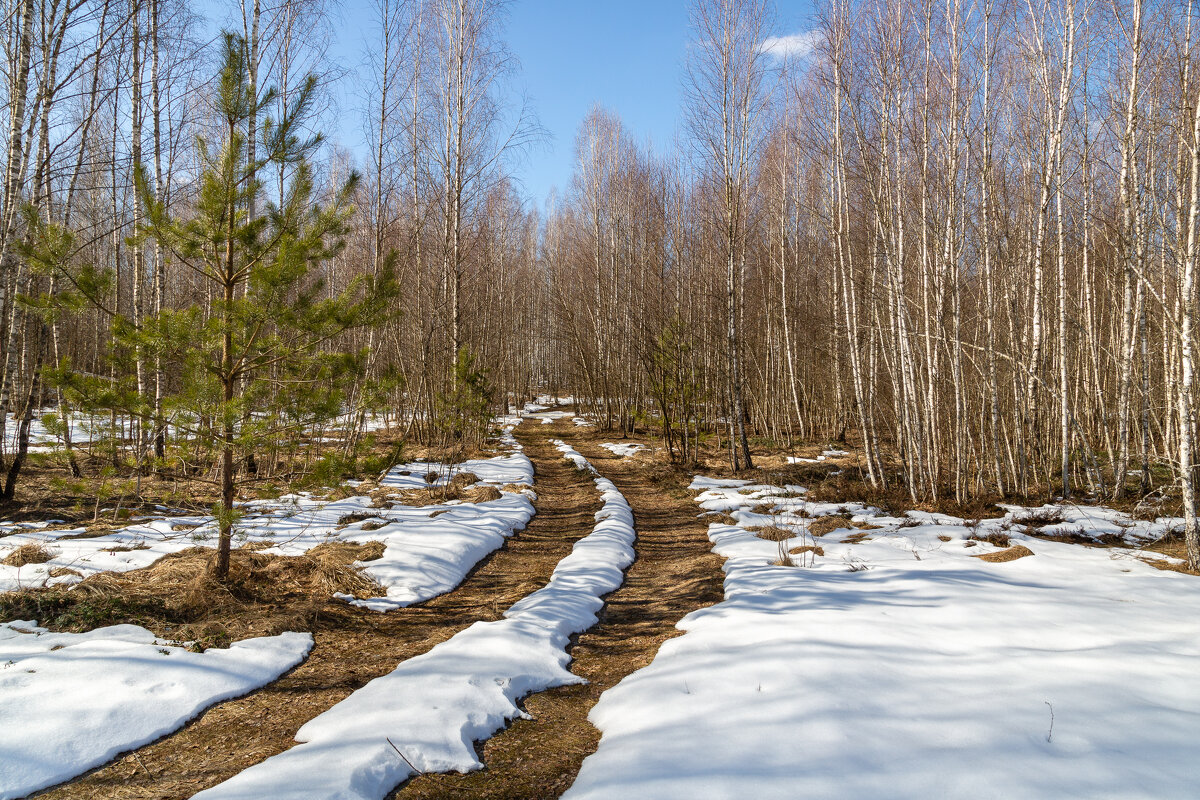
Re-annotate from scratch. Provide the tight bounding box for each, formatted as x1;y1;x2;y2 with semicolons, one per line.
0;621;312;800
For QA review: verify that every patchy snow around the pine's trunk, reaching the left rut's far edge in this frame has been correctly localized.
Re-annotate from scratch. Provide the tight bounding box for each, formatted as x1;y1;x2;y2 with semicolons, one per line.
0;452;534;610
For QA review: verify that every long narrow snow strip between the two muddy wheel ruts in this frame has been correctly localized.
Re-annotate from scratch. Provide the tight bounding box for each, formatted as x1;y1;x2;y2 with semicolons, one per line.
196;445;635;800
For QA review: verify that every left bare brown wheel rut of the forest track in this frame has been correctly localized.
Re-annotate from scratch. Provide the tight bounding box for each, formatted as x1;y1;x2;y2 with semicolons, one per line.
34;421;600;800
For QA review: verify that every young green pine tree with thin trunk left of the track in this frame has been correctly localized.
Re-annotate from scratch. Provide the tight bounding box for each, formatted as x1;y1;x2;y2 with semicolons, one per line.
132;34;396;581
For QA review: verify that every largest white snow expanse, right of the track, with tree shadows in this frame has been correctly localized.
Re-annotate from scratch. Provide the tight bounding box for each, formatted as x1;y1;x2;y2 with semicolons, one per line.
564;479;1200;800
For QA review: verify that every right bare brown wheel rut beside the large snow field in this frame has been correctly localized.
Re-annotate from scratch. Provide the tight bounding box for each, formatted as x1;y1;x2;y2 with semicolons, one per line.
391;425;722;800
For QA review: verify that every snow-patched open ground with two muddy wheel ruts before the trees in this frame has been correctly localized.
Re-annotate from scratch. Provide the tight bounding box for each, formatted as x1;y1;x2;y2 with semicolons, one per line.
0;407;1200;800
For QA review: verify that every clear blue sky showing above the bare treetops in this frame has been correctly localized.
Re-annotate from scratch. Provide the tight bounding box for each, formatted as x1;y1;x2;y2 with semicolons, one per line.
206;0;812;206
